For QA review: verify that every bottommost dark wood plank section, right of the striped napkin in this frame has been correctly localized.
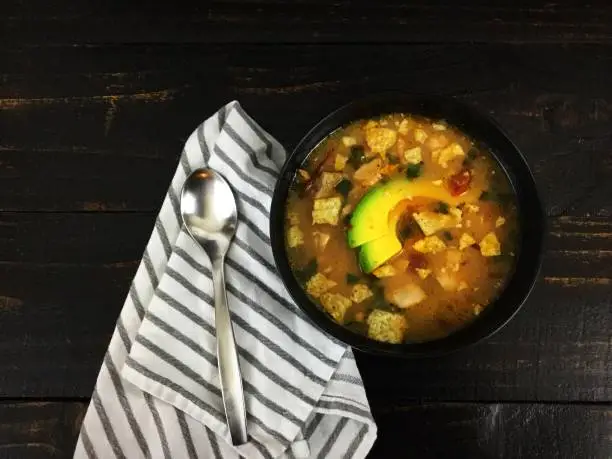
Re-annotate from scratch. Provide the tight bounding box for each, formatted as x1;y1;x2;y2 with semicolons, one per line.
368;403;612;459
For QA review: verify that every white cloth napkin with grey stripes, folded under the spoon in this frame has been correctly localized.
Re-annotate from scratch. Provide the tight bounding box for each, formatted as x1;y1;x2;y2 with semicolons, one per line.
74;102;376;459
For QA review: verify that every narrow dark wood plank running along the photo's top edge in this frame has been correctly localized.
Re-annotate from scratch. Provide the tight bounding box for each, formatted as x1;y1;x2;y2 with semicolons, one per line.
5;0;612;44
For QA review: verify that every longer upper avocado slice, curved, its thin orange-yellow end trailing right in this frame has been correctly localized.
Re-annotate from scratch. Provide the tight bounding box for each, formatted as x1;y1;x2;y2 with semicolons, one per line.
348;178;482;247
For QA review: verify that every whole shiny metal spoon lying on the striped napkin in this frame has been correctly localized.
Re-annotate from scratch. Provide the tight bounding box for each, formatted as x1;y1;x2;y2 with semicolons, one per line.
181;169;247;445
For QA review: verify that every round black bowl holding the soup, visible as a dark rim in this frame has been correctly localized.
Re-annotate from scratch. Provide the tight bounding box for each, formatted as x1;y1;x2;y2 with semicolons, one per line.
270;94;544;357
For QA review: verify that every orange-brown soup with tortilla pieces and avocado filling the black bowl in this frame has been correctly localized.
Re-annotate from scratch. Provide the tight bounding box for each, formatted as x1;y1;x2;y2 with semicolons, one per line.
285;113;518;343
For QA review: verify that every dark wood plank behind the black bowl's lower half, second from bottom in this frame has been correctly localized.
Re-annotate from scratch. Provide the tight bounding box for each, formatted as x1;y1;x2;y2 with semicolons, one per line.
0;212;612;398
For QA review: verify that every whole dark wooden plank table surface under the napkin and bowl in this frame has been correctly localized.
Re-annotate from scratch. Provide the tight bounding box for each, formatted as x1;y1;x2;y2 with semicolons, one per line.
0;0;612;459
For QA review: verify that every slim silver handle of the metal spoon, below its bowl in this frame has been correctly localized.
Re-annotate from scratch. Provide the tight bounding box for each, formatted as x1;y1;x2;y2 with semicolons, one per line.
212;257;247;445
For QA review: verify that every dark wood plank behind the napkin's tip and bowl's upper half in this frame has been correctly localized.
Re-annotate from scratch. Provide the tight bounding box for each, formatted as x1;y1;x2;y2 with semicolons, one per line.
0;45;612;218
